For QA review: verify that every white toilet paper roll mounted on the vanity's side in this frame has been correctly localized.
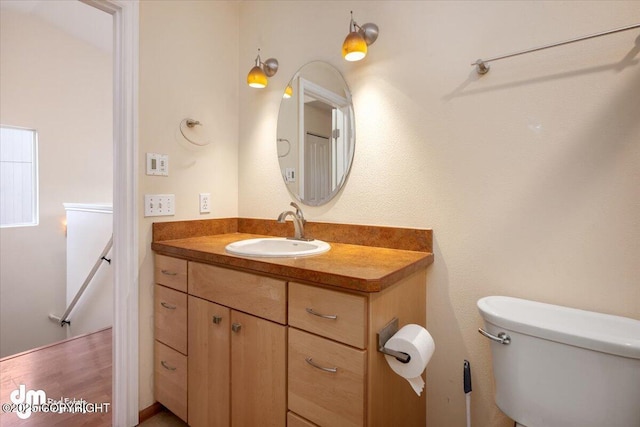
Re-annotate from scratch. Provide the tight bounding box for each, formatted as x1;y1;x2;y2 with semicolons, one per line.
384;324;436;396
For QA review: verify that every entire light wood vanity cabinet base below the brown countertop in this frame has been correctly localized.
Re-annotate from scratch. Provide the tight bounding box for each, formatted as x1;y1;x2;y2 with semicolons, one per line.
155;255;426;427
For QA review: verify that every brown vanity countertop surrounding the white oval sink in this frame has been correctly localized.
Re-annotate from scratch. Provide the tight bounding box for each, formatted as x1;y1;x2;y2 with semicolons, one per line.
151;220;433;292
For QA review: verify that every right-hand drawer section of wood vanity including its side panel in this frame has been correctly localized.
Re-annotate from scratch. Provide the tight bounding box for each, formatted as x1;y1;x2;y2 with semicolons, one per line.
287;278;426;427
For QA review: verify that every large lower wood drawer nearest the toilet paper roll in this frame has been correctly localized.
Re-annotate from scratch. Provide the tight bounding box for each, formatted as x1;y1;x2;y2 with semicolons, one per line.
288;328;366;427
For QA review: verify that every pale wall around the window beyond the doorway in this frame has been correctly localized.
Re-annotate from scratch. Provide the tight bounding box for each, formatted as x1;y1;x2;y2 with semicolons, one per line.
0;2;113;357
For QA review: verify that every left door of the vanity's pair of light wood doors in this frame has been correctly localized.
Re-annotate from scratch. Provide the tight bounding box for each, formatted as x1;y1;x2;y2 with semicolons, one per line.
188;296;231;427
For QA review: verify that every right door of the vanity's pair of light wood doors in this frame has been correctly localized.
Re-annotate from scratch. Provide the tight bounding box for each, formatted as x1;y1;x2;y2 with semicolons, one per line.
231;311;287;427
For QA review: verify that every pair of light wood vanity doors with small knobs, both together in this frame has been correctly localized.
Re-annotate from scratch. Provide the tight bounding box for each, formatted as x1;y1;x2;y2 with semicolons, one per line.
188;296;286;427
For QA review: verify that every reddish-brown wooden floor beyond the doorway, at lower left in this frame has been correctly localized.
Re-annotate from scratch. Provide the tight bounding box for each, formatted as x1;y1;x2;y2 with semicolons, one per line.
0;328;113;427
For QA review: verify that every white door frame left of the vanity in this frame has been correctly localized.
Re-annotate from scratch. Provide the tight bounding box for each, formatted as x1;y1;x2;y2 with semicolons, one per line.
80;0;139;426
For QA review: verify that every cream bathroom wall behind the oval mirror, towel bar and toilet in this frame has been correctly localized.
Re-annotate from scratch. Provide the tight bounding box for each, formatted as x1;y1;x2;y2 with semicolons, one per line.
236;1;640;427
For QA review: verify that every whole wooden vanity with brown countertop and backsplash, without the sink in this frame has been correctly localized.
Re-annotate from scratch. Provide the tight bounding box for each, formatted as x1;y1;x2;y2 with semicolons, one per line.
152;218;433;427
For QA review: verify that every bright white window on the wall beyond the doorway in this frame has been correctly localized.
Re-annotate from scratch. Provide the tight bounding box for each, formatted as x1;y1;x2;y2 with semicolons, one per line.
0;125;38;227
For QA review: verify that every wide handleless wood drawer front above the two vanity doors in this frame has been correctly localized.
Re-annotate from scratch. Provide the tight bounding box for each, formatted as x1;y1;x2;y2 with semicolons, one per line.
189;262;287;325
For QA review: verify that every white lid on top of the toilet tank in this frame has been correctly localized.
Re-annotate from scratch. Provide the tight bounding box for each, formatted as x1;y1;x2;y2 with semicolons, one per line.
478;296;640;359
